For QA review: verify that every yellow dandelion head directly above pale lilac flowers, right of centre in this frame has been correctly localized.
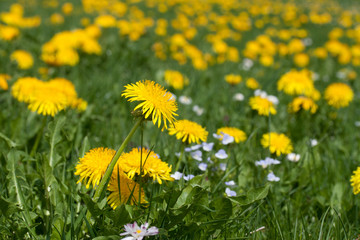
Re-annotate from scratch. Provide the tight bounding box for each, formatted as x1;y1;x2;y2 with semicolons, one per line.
261;132;293;156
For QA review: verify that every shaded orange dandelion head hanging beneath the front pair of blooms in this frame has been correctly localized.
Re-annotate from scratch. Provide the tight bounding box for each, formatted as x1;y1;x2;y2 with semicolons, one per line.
107;168;147;209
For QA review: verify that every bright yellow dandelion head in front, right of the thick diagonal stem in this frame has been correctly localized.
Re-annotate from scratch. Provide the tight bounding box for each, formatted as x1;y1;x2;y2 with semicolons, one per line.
117;148;174;184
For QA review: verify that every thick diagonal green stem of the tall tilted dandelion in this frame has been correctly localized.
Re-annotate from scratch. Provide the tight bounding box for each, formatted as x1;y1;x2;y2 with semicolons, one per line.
90;118;143;202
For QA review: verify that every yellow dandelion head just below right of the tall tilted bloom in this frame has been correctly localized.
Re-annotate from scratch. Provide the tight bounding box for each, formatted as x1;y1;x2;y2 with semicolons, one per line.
169;120;209;144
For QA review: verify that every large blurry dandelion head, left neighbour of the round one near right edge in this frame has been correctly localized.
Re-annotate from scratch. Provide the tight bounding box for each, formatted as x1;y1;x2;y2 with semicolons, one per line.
277;70;314;96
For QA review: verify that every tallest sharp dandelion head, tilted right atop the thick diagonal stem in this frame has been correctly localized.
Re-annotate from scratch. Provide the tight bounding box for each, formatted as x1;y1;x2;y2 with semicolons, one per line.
122;80;177;128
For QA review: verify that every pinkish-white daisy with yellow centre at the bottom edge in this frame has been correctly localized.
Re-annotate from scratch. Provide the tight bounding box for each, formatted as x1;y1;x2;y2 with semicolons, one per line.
120;222;159;240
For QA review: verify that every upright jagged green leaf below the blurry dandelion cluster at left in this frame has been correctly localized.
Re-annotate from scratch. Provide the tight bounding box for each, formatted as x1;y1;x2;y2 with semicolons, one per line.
48;116;66;167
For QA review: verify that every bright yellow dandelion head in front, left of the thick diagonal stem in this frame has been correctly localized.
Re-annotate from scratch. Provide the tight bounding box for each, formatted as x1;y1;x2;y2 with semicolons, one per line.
75;147;116;188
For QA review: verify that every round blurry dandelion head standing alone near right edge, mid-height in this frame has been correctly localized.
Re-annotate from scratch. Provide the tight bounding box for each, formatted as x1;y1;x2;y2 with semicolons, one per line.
324;83;354;108
